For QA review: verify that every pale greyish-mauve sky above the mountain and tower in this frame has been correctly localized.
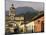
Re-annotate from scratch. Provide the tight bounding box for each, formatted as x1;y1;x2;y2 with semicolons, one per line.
5;0;44;11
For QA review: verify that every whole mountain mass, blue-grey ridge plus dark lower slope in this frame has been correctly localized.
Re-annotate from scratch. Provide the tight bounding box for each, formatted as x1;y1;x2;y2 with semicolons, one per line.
16;7;39;21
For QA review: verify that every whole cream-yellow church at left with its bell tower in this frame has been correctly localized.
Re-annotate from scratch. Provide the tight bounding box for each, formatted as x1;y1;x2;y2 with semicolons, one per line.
5;4;24;33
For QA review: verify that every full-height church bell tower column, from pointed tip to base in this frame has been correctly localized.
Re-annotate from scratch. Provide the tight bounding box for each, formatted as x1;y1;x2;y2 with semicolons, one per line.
8;4;16;32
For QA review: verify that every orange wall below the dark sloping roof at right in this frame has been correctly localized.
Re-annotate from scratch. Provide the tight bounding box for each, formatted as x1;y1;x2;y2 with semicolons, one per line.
34;16;44;32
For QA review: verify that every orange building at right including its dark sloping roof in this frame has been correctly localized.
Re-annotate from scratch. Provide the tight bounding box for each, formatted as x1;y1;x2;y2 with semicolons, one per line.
33;13;44;32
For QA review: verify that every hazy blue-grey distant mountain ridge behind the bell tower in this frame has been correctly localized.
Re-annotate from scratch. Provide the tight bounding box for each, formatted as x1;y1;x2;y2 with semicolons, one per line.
5;7;37;15
